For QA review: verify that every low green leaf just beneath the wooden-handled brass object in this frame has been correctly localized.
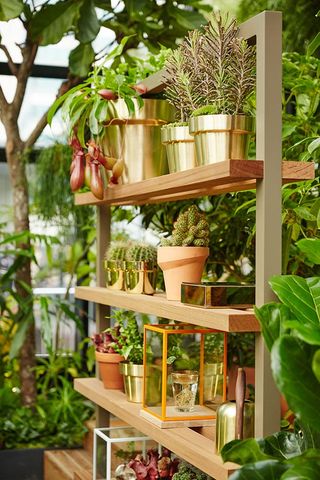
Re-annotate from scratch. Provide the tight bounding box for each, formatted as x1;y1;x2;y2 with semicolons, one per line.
221;438;271;465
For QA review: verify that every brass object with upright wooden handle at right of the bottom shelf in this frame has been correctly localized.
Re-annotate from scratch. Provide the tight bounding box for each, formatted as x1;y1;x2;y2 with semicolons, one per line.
216;368;254;453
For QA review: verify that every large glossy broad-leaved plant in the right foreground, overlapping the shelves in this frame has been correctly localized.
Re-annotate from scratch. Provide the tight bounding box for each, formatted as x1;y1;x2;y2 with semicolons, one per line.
221;239;320;480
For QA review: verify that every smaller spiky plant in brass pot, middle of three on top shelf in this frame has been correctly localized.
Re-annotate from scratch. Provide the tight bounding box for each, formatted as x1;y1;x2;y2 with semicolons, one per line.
161;30;200;173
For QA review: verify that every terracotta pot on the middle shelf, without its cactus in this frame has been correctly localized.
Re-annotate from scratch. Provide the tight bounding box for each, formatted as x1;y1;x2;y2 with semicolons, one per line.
158;247;209;301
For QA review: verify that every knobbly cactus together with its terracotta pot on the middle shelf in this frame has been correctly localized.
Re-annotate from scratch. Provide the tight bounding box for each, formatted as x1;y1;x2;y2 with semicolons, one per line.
158;205;210;301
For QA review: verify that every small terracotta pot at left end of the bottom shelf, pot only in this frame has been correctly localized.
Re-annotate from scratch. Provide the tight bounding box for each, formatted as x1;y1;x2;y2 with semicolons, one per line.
96;352;124;390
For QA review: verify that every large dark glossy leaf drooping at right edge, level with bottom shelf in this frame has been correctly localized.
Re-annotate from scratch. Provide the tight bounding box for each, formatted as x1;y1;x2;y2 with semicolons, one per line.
271;335;320;431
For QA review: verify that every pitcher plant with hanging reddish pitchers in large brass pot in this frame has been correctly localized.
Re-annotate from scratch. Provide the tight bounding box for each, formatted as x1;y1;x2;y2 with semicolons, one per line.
48;37;174;199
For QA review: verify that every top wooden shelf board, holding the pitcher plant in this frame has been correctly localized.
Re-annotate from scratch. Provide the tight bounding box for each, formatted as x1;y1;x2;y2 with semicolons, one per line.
75;160;314;205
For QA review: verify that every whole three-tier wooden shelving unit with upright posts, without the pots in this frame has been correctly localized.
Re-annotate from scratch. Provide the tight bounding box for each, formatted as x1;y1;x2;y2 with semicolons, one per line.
75;12;314;480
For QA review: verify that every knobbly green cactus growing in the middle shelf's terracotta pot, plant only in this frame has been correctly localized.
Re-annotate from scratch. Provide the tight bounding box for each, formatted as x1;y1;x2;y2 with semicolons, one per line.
161;205;210;247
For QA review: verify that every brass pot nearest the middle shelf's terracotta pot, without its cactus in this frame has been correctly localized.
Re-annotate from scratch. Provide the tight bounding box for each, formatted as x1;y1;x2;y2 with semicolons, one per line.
125;262;157;295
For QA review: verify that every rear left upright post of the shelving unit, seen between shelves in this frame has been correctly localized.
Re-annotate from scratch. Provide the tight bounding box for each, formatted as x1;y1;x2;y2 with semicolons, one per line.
96;205;111;427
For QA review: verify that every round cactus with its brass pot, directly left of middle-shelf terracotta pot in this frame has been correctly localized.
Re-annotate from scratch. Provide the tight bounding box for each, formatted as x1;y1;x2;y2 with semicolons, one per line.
125;242;157;295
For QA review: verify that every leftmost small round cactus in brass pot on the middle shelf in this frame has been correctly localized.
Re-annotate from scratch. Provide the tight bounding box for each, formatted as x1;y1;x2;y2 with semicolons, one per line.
104;241;130;290
